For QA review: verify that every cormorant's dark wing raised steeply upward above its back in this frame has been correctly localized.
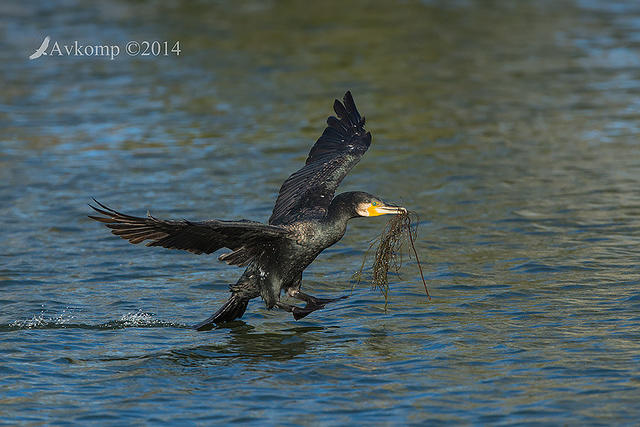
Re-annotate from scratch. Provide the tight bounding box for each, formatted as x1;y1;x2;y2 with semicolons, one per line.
269;92;371;224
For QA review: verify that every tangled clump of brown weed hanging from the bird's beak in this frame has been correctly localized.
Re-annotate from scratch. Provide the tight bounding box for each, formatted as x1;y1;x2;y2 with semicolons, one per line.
353;212;431;312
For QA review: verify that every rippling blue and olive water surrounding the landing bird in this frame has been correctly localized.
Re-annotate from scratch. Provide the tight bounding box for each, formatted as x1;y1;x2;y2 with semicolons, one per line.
0;0;640;425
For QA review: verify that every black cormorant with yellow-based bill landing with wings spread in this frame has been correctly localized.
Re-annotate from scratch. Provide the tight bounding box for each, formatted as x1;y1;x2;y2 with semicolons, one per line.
89;92;406;330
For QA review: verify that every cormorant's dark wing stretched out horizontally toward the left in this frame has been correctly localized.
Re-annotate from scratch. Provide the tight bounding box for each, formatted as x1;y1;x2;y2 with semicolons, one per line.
89;199;290;265
